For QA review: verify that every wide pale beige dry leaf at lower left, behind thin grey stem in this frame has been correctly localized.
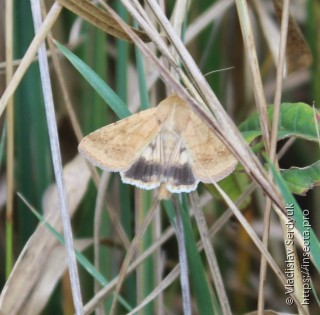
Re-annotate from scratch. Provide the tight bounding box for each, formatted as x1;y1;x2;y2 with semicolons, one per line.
0;156;90;315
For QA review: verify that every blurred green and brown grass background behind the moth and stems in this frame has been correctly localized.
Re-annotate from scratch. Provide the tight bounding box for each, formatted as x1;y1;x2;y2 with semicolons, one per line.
0;0;320;315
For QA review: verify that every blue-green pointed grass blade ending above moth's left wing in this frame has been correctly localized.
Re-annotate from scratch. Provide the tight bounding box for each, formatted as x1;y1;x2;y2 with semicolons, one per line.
55;41;131;119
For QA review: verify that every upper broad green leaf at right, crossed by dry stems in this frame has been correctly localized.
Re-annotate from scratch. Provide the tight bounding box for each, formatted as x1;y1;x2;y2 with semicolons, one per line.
239;103;318;143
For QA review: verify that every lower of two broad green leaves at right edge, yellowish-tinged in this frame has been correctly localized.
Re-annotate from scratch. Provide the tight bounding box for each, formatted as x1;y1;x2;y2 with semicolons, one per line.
281;161;320;195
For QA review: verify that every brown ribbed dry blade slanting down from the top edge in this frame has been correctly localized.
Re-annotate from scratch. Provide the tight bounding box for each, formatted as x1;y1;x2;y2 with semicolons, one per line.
58;0;150;42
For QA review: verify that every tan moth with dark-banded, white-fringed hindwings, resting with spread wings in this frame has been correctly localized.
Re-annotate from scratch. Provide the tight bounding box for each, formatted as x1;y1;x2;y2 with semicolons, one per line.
78;95;238;193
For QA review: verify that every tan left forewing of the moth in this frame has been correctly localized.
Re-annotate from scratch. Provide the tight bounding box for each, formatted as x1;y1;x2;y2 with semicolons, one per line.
78;108;160;172
